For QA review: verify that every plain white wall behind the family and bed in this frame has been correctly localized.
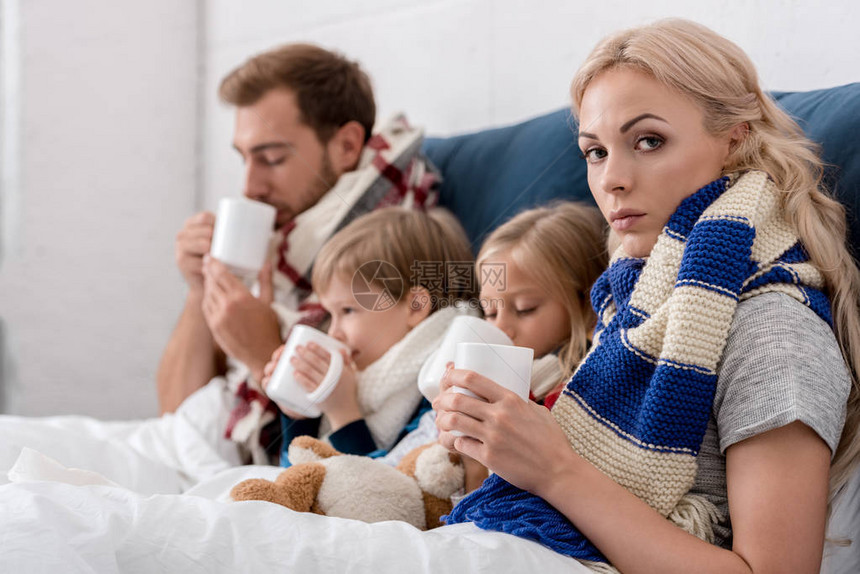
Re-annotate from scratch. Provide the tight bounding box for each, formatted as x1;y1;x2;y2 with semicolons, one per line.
0;0;860;424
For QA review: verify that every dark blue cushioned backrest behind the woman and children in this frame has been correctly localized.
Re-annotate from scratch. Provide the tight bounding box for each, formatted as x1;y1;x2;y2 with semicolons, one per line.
424;83;860;254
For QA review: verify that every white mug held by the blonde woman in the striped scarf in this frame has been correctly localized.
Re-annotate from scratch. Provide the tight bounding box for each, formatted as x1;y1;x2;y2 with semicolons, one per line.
451;343;535;436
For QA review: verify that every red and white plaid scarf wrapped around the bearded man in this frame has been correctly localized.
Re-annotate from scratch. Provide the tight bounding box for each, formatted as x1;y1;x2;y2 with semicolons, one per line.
224;115;441;464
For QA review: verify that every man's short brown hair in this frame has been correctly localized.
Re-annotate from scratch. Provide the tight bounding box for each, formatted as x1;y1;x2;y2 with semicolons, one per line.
218;44;376;143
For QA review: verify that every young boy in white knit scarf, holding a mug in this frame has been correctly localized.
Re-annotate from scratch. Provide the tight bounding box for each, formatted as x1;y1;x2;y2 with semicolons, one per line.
262;208;474;465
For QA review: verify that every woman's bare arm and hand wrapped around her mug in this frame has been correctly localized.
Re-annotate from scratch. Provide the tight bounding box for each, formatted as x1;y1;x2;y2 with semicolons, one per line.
440;369;830;574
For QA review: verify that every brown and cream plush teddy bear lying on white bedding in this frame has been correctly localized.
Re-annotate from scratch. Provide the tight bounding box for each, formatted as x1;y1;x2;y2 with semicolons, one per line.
230;436;465;530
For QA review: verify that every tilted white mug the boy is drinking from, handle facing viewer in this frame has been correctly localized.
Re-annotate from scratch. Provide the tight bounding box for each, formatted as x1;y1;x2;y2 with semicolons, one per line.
266;325;349;417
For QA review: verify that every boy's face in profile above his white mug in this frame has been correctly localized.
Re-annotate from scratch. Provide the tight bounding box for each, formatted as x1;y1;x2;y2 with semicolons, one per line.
317;276;420;371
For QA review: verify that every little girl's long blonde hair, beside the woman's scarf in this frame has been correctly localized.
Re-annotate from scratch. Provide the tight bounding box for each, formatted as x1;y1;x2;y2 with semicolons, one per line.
476;201;607;378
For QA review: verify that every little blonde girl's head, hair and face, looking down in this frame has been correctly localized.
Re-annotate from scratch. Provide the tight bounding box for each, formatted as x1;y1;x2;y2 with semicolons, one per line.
476;202;607;406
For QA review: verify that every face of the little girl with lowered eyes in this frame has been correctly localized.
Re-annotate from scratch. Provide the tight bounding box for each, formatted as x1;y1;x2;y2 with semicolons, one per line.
481;255;570;358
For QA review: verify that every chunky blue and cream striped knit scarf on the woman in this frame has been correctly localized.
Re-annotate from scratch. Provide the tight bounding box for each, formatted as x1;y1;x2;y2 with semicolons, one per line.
447;172;831;571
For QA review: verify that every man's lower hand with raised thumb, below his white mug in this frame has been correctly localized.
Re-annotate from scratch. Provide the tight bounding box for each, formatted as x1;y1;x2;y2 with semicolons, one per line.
202;257;281;381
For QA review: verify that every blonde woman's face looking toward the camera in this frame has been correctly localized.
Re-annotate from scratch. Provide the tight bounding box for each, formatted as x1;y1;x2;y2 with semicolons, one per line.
579;68;732;257
